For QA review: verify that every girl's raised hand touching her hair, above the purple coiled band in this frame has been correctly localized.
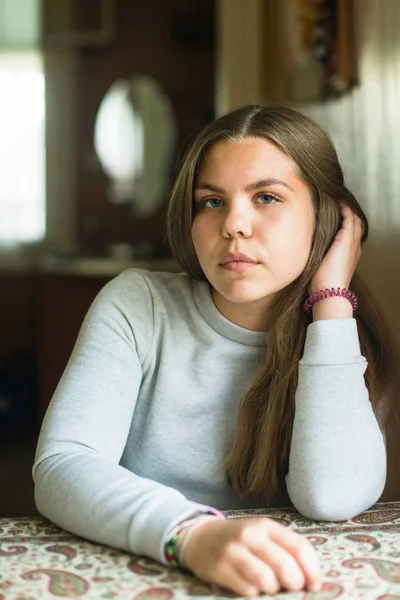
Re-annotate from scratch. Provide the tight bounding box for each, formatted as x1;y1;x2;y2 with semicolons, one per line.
310;204;363;293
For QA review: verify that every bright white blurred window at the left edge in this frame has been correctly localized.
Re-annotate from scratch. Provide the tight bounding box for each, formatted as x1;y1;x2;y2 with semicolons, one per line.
0;50;46;246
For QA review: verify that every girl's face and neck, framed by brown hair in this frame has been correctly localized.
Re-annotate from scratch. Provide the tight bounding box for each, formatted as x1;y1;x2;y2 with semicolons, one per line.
192;137;315;330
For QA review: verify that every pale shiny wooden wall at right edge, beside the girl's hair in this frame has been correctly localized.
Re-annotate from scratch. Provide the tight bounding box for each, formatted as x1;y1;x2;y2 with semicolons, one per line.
303;0;400;500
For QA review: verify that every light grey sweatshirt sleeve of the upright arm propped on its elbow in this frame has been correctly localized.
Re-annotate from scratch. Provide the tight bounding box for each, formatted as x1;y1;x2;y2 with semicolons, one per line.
286;319;386;521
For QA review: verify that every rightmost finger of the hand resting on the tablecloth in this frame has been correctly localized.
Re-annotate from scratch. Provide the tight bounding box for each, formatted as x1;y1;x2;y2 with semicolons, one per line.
268;521;321;590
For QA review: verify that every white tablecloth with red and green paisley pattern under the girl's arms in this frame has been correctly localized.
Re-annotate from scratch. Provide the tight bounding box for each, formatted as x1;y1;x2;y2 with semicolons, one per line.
0;502;400;600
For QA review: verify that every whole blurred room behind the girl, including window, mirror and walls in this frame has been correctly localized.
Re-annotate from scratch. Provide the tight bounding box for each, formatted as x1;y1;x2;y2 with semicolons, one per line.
0;0;400;516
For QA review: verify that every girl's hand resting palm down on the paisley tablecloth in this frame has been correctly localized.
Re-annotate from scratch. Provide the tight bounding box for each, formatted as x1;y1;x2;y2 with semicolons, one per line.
182;518;321;596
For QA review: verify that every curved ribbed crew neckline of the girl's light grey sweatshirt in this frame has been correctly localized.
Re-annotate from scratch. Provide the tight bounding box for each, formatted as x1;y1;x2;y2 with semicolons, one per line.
192;280;268;346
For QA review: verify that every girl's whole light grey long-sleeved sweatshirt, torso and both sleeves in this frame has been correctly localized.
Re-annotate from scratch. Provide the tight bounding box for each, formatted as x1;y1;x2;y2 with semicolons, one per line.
33;269;386;562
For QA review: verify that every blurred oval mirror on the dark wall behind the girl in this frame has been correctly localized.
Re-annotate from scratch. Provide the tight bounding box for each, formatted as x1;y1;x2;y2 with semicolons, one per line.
94;75;176;218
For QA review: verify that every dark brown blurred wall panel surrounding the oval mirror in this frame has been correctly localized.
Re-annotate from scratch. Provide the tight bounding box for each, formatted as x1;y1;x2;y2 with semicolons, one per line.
76;0;215;253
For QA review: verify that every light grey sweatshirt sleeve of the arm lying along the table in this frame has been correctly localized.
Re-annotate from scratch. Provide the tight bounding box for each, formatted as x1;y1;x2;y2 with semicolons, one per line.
33;273;220;563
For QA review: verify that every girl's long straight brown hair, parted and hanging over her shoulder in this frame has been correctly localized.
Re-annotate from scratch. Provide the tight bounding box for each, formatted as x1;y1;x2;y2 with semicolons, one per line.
167;105;398;503
